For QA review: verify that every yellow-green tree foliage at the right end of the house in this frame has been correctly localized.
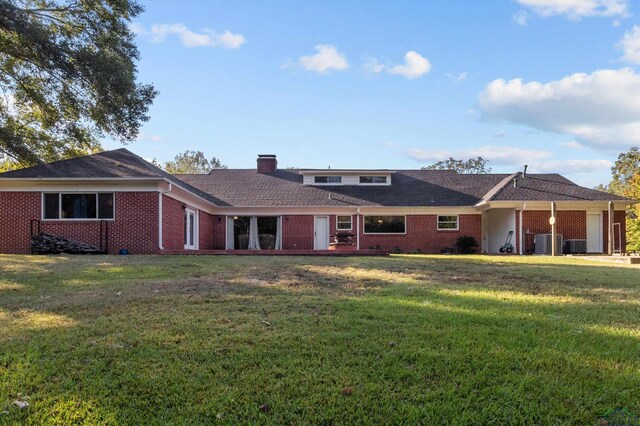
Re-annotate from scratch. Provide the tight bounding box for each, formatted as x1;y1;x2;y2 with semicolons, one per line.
596;146;640;251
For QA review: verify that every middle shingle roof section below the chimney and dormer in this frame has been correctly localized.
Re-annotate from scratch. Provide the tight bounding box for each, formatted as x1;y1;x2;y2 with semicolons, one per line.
177;169;508;207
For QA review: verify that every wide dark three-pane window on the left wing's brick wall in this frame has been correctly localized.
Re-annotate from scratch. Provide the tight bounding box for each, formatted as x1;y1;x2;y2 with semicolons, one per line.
42;192;113;219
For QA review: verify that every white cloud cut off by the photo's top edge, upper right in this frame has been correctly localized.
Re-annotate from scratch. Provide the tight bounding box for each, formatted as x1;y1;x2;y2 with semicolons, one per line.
518;0;629;23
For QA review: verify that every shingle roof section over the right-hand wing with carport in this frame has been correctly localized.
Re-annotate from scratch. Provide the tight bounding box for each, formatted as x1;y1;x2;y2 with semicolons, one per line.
490;173;633;201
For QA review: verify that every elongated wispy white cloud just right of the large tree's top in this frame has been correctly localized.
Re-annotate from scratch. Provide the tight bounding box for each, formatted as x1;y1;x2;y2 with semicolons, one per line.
134;23;246;49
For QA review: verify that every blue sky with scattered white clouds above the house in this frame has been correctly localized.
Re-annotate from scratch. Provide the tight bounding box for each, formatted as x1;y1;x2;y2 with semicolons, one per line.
105;0;640;186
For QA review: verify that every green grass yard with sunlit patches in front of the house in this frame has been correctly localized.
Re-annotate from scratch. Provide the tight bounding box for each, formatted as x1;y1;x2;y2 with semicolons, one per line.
0;255;640;425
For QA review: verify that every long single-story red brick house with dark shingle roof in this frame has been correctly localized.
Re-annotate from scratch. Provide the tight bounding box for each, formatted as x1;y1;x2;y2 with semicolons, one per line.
0;149;636;254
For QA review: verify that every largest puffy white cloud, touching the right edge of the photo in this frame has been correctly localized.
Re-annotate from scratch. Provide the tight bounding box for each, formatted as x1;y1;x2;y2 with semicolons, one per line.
478;68;640;149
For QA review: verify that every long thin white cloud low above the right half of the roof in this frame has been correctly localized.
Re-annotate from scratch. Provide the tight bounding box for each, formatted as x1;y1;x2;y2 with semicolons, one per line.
407;145;552;166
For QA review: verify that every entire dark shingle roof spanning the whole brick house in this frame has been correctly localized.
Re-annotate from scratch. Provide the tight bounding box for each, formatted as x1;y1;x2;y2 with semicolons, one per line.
0;148;633;207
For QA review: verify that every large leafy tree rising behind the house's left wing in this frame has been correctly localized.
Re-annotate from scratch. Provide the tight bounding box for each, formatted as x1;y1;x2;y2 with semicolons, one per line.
0;0;157;167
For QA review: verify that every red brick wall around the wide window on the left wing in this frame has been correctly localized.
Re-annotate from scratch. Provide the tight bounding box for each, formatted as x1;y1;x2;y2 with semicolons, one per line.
0;192;158;254
